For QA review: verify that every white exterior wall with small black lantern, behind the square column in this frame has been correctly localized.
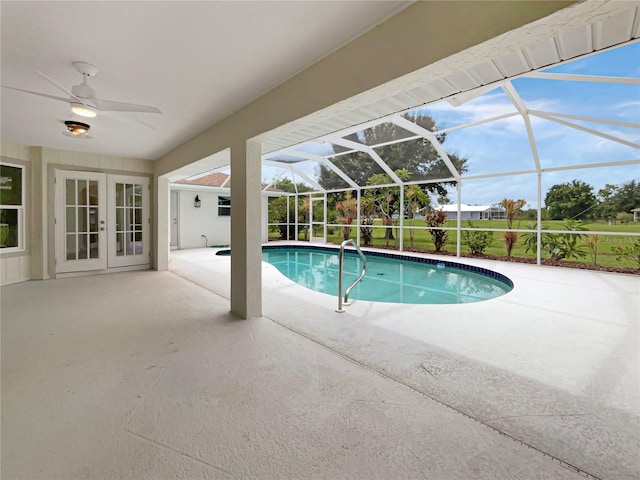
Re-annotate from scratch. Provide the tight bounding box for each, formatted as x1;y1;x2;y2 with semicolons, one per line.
171;185;269;249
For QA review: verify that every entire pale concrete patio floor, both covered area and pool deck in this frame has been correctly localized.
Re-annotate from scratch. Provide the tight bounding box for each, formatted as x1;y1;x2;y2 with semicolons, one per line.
1;249;640;479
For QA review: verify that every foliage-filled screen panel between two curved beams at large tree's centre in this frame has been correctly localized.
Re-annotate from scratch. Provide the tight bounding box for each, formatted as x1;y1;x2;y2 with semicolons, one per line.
374;138;458;182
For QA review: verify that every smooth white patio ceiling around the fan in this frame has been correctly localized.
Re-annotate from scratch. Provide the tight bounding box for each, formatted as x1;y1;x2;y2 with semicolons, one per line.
0;0;409;159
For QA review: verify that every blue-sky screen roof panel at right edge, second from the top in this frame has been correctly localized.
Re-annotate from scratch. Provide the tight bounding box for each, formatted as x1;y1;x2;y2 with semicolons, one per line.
512;78;640;122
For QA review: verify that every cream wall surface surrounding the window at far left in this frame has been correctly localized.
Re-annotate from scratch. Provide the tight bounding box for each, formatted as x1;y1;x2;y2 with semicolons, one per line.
0;140;33;285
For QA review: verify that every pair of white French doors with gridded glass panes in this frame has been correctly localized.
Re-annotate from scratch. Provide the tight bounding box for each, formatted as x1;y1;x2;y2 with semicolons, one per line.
55;170;150;273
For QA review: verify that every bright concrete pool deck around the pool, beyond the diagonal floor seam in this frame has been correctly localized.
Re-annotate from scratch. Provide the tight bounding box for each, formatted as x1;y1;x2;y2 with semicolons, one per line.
171;249;640;479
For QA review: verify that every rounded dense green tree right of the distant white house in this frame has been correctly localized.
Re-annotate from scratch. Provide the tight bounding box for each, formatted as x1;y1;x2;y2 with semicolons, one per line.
544;180;598;220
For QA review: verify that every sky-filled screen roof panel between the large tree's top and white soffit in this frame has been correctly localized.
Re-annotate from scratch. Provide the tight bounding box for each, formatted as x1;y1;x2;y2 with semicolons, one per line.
404;88;516;130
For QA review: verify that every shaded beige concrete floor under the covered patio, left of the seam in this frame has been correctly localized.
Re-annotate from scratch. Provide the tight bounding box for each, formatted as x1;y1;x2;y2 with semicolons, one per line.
1;259;596;479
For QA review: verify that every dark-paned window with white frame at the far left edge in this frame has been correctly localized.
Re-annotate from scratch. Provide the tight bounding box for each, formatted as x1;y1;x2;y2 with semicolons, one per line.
0;162;24;252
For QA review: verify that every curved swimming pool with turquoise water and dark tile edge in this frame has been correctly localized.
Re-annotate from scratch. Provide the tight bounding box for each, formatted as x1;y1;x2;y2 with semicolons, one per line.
218;246;513;304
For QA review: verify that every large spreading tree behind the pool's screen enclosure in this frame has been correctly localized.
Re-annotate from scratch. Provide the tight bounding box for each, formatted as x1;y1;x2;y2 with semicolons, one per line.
318;114;467;196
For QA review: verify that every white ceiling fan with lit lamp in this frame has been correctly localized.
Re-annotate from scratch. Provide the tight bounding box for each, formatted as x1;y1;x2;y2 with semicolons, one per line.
2;62;162;118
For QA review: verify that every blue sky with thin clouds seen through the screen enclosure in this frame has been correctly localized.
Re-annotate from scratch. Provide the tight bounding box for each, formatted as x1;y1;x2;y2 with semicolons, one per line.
263;39;640;208
